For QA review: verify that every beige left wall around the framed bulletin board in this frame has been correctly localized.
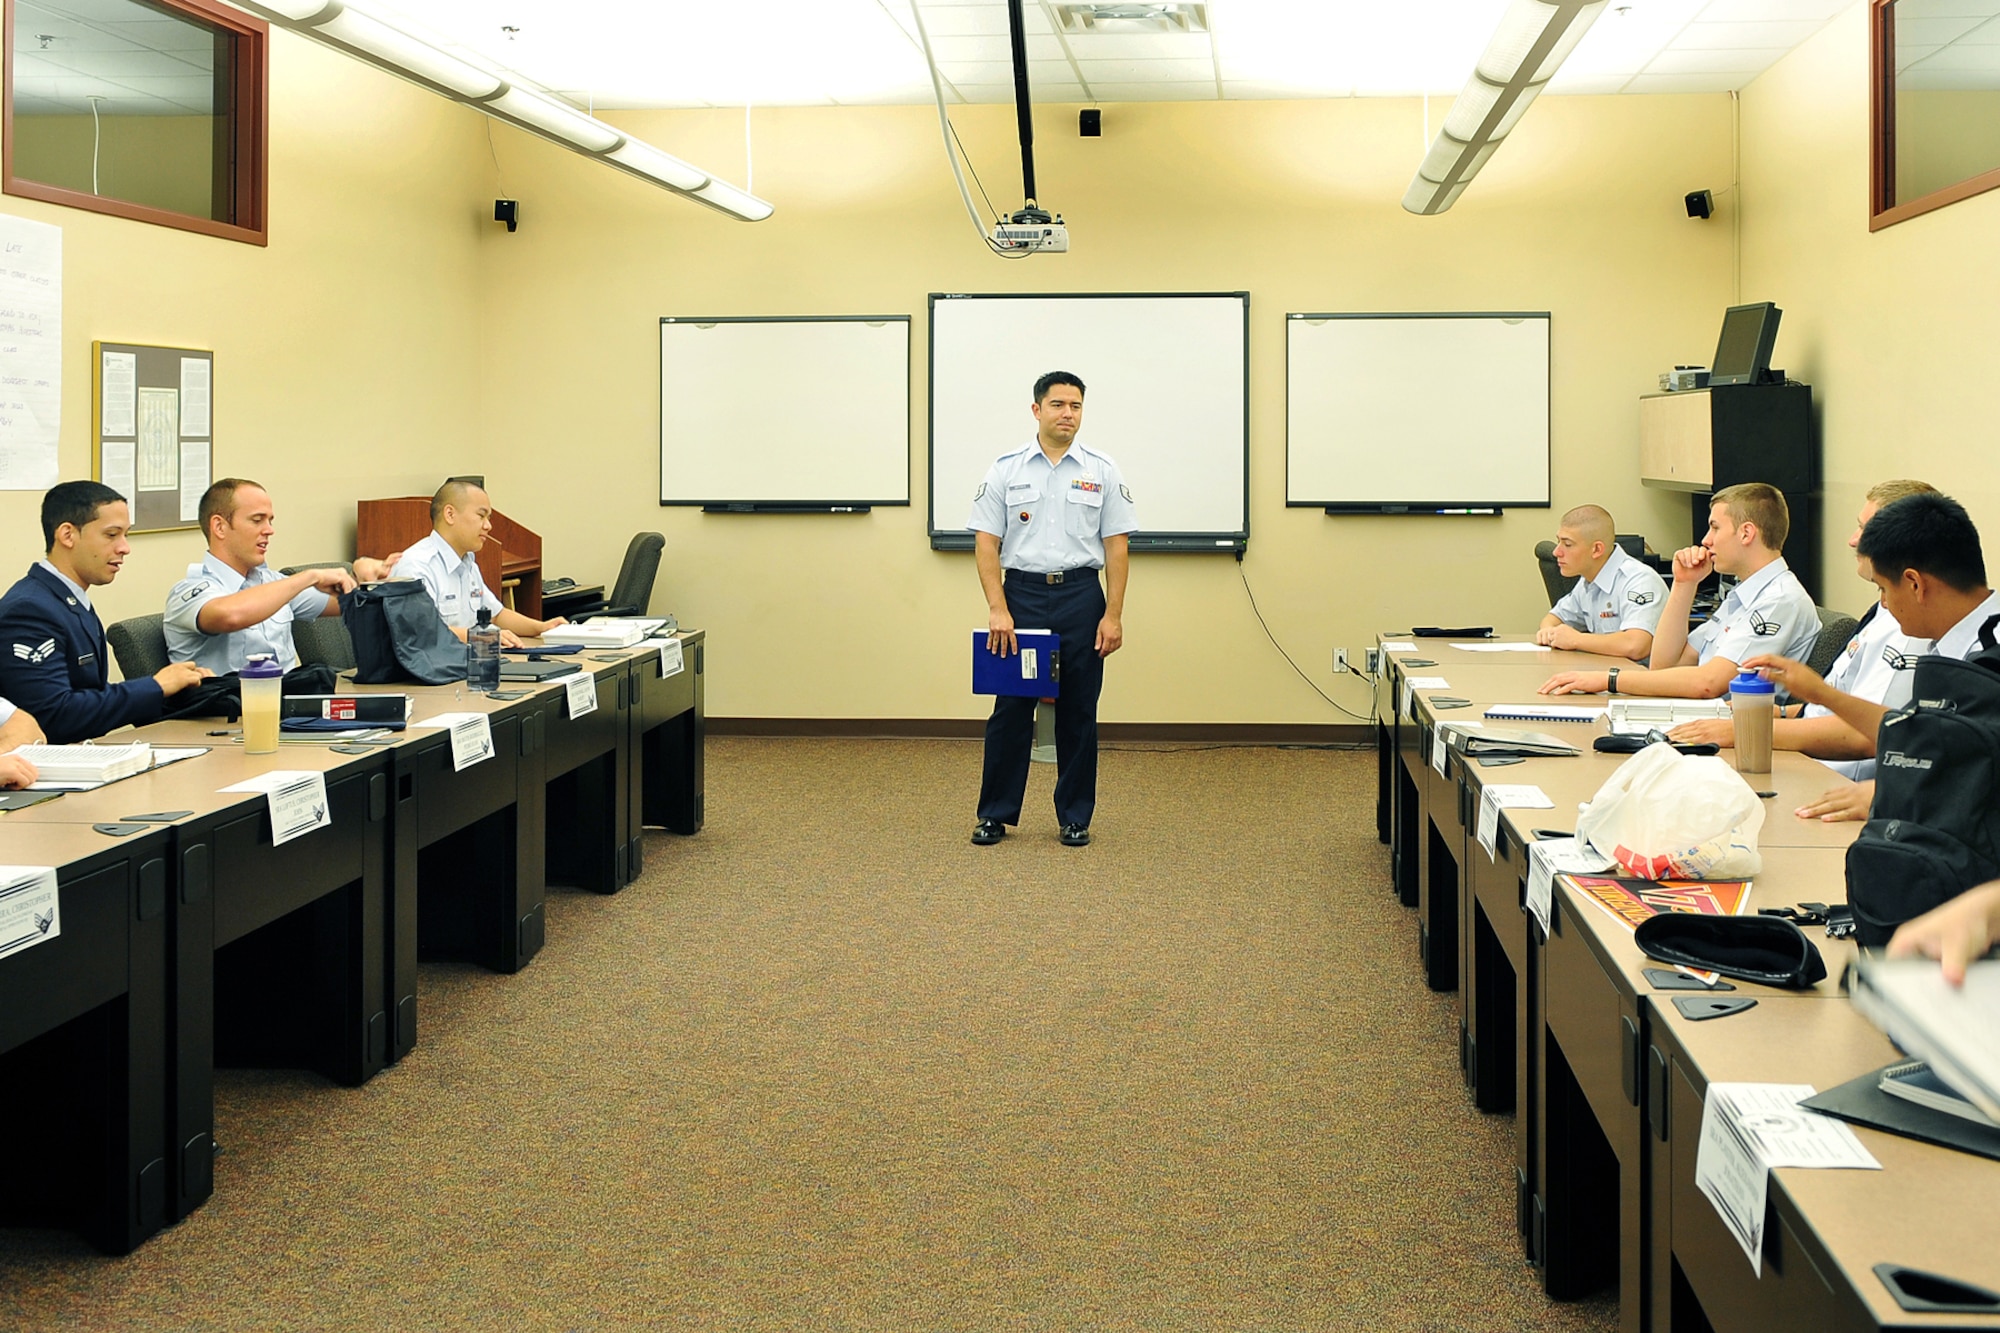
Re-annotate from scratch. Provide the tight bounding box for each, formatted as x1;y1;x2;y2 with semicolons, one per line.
0;32;492;622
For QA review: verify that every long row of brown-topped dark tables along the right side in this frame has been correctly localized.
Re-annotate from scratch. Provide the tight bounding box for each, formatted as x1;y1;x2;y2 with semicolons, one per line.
1378;624;2000;1333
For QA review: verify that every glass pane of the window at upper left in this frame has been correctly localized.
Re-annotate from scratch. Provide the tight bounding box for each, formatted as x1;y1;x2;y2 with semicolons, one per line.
12;0;236;222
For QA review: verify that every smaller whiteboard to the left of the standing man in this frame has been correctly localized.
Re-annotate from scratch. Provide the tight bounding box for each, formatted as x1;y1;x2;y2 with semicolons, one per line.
660;314;910;510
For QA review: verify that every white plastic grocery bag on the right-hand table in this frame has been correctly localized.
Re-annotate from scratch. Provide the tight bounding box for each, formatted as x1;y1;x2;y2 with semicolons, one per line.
1576;743;1764;879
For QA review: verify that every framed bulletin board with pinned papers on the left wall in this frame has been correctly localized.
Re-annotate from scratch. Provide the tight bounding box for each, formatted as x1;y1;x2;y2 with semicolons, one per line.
90;342;216;532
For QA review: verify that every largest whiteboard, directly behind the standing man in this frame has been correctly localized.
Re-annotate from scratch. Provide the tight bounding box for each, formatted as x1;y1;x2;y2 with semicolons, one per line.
930;292;1250;550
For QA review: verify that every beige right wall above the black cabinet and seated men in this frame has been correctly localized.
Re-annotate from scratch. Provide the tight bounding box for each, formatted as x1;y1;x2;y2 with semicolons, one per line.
1742;4;2000;608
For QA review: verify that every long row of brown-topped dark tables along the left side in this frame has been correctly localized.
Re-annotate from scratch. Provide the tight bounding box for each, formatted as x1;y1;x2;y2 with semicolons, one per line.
0;630;706;1253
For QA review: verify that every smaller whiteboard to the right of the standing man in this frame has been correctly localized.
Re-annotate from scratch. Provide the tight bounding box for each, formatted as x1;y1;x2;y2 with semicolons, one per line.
1284;310;1550;512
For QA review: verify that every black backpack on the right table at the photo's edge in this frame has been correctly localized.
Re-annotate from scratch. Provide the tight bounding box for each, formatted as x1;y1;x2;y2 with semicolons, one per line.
1848;616;2000;947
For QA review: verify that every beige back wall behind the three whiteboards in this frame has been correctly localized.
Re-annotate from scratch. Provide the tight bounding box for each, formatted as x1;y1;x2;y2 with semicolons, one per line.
480;96;1730;723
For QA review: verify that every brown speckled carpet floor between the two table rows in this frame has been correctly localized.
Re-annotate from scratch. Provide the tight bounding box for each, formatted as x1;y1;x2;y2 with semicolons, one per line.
0;739;1616;1329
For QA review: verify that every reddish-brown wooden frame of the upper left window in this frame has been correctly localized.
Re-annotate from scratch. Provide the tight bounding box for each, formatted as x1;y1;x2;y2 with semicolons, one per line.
0;0;270;246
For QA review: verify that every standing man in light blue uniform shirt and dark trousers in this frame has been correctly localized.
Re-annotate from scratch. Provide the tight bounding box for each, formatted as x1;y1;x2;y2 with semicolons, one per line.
966;370;1138;847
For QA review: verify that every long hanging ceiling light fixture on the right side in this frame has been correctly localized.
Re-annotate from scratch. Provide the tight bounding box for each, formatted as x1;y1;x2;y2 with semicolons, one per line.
1402;0;1606;214
